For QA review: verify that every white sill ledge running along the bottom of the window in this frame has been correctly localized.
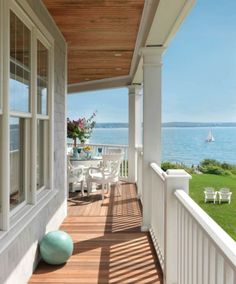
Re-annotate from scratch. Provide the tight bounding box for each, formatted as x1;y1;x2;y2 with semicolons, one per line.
0;189;58;253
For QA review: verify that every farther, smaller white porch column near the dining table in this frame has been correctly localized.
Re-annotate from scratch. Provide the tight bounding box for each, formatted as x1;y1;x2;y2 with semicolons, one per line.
128;85;142;182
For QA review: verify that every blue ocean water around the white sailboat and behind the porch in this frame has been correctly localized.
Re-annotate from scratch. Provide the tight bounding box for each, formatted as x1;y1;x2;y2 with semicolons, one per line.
90;127;236;165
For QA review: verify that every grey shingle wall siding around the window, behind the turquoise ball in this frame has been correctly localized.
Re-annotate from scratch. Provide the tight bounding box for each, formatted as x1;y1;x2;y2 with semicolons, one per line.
0;0;67;284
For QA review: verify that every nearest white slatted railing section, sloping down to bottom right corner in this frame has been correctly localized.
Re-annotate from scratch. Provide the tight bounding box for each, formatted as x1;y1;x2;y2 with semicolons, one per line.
175;190;236;284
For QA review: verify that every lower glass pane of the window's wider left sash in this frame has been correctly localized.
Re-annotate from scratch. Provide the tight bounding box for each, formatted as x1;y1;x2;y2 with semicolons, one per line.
10;117;25;209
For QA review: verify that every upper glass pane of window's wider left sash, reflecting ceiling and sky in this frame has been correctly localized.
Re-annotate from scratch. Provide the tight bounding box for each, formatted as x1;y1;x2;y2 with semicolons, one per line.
10;12;31;112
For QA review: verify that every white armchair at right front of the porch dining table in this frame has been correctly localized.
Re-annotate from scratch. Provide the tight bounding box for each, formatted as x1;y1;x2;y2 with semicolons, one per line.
86;154;123;201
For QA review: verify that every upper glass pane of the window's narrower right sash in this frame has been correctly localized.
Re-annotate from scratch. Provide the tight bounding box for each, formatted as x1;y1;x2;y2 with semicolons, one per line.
37;41;48;114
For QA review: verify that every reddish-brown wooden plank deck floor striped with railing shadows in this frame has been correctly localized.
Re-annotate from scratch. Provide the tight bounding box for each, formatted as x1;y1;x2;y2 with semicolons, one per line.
29;184;162;284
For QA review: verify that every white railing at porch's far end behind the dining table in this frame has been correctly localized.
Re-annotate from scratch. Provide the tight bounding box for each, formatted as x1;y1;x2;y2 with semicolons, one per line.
67;143;129;180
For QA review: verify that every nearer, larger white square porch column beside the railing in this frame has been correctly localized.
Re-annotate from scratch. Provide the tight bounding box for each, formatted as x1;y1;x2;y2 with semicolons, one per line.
141;47;164;231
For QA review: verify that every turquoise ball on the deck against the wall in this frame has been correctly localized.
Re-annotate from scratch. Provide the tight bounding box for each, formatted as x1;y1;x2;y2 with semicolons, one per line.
39;231;73;265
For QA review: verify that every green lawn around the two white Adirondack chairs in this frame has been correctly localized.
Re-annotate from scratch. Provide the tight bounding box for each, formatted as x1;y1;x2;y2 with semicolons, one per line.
189;174;236;241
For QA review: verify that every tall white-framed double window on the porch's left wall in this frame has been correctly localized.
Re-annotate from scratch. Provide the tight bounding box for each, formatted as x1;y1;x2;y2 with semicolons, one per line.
0;0;53;230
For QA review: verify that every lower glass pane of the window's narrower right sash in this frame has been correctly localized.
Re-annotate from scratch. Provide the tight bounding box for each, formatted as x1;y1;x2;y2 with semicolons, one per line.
37;120;48;189
